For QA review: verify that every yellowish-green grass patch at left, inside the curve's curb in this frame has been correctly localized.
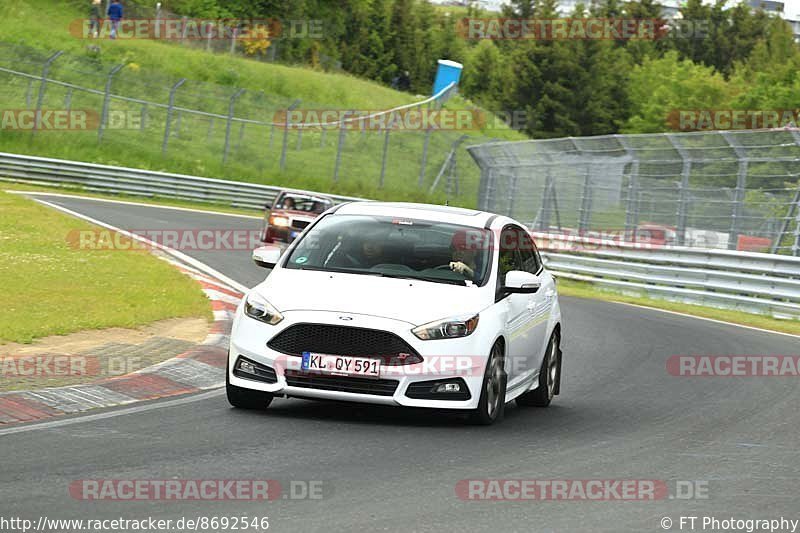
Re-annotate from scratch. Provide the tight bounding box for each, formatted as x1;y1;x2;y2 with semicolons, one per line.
0;192;211;342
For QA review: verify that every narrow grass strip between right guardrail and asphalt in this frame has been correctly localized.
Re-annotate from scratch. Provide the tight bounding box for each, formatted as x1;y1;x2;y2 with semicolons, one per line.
558;278;800;335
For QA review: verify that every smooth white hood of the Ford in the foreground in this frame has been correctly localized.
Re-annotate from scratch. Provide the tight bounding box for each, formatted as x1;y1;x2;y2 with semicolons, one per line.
254;268;487;326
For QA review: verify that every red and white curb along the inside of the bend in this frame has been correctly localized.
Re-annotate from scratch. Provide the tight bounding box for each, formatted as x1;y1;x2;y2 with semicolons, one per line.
0;251;243;425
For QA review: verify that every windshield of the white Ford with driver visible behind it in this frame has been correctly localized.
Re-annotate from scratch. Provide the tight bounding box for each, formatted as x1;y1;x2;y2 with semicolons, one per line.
285;215;491;286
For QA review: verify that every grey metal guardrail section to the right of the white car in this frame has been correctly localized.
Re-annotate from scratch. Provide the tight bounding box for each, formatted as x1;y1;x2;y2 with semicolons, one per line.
532;232;800;319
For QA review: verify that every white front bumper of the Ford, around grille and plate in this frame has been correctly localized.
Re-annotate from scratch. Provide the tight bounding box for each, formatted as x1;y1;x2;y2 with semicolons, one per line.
227;307;491;409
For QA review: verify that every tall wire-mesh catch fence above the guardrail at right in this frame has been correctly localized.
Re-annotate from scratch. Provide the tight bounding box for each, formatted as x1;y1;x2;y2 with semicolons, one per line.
467;128;800;256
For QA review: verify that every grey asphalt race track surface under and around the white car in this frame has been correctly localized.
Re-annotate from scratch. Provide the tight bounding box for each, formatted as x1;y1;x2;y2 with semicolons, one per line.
0;197;800;533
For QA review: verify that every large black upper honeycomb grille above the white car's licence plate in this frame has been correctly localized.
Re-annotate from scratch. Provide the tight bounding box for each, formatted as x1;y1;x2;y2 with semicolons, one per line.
267;324;422;366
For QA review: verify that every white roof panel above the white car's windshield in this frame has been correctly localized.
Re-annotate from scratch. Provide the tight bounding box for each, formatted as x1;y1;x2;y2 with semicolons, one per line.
336;202;496;228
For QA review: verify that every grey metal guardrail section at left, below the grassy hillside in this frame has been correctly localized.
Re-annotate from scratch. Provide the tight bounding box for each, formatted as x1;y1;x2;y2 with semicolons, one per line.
0;152;363;209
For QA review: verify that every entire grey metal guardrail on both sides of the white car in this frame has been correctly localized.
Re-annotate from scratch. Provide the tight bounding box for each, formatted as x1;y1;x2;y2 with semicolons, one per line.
0;148;800;319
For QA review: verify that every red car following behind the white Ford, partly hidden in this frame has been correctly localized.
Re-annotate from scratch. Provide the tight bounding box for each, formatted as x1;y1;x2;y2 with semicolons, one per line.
261;191;333;244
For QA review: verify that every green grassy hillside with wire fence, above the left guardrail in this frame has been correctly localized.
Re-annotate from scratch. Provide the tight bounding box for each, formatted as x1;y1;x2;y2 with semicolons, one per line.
0;0;524;206
